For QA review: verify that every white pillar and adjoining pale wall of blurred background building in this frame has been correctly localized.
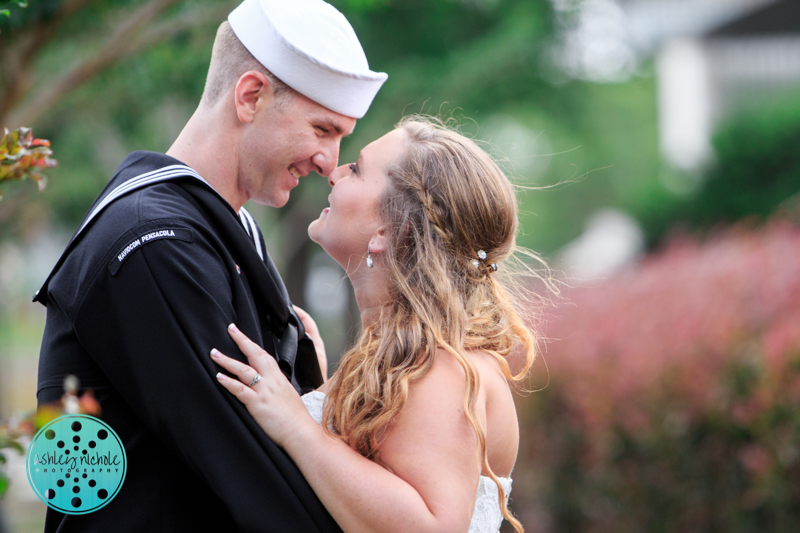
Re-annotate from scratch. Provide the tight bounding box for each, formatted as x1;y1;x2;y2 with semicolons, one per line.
656;0;800;170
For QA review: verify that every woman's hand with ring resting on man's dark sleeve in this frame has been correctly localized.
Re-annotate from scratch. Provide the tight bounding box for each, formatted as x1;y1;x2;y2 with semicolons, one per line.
211;324;319;447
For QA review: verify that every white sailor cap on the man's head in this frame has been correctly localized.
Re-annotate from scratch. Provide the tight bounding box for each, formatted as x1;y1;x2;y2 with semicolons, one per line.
228;0;388;118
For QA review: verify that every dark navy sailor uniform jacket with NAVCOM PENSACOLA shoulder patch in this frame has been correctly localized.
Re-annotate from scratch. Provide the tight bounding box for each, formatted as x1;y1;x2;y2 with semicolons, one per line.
35;152;339;533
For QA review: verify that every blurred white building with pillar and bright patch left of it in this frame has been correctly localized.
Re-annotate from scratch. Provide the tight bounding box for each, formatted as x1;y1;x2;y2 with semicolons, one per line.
551;0;800;170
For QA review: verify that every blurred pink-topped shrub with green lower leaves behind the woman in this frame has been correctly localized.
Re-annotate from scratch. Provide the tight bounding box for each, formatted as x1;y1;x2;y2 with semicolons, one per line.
512;221;800;533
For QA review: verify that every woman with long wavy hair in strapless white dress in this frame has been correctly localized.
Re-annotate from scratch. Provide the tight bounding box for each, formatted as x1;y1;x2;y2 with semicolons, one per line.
212;116;548;533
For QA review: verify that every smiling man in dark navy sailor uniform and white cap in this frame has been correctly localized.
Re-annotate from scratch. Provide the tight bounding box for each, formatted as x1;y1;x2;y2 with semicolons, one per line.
35;0;386;533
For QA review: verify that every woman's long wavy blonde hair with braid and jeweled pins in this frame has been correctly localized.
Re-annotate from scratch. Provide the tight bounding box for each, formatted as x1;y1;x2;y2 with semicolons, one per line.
323;115;536;531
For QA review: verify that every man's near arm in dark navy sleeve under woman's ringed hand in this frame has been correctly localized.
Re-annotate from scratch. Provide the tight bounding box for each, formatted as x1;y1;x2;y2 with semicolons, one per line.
59;220;338;531
